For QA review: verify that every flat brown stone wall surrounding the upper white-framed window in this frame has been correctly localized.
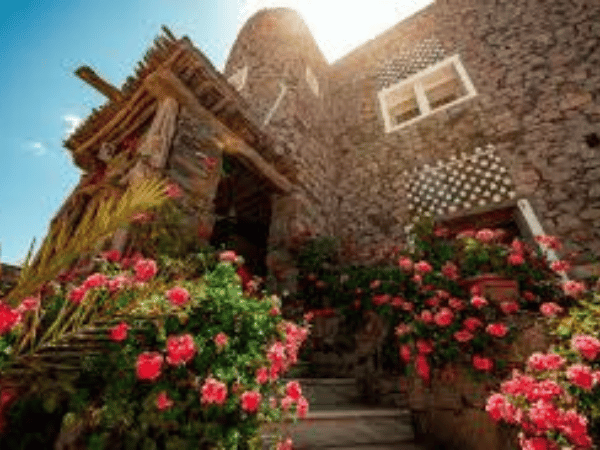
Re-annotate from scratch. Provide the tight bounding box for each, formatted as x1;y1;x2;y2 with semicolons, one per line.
324;0;600;260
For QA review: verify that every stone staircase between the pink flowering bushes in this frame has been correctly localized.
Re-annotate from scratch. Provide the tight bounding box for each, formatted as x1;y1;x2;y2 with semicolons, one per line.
263;377;425;450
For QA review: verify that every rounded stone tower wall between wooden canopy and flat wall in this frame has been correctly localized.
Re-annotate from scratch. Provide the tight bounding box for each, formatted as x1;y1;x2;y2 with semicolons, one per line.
225;8;337;247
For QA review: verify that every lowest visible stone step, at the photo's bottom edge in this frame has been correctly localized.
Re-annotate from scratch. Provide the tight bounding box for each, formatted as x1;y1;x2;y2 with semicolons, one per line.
262;407;422;450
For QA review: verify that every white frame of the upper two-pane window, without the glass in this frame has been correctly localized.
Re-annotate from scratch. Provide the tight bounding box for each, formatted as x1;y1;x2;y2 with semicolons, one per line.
377;55;477;133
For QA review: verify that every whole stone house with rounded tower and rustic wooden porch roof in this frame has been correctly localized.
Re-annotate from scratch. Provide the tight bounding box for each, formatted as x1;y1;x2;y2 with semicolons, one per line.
58;0;600;278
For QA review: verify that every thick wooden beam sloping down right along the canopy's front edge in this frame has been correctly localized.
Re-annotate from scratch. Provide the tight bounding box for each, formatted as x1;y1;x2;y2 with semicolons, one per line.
145;68;292;193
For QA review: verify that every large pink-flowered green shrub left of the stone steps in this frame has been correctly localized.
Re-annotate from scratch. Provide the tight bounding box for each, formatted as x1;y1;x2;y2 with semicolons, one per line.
0;252;308;449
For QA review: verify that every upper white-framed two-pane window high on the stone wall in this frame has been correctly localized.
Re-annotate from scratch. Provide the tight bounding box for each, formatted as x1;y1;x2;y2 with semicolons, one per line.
378;55;477;133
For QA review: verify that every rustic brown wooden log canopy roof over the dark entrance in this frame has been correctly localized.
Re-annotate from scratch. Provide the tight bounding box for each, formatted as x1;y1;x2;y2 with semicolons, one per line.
64;26;294;193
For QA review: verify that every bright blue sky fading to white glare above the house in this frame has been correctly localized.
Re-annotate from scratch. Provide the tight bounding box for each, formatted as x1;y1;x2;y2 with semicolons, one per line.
0;0;429;264
